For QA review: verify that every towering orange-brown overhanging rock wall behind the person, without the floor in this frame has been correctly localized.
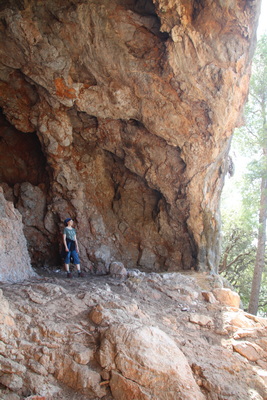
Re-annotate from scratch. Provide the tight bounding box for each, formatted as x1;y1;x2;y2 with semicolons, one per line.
0;0;260;272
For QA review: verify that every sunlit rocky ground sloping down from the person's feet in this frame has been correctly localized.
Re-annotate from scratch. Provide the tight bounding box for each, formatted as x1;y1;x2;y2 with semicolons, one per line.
0;270;267;400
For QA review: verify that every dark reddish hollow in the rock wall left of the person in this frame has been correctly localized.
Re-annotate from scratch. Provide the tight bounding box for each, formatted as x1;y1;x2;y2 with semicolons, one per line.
0;110;59;267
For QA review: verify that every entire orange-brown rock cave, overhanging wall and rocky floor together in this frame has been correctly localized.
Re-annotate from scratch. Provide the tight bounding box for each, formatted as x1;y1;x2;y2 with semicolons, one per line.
0;0;267;400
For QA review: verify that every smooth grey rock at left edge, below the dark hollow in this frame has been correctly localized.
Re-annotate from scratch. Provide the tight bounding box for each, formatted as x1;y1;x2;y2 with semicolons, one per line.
0;187;35;282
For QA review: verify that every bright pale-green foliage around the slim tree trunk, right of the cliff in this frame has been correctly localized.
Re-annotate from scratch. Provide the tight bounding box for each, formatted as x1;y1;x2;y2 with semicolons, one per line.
220;34;267;315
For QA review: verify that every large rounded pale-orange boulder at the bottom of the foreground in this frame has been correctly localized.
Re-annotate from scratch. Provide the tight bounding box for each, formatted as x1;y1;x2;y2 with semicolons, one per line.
100;324;205;400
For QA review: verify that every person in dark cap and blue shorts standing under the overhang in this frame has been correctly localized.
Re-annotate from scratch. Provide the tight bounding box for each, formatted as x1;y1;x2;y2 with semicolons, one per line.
63;218;83;278
